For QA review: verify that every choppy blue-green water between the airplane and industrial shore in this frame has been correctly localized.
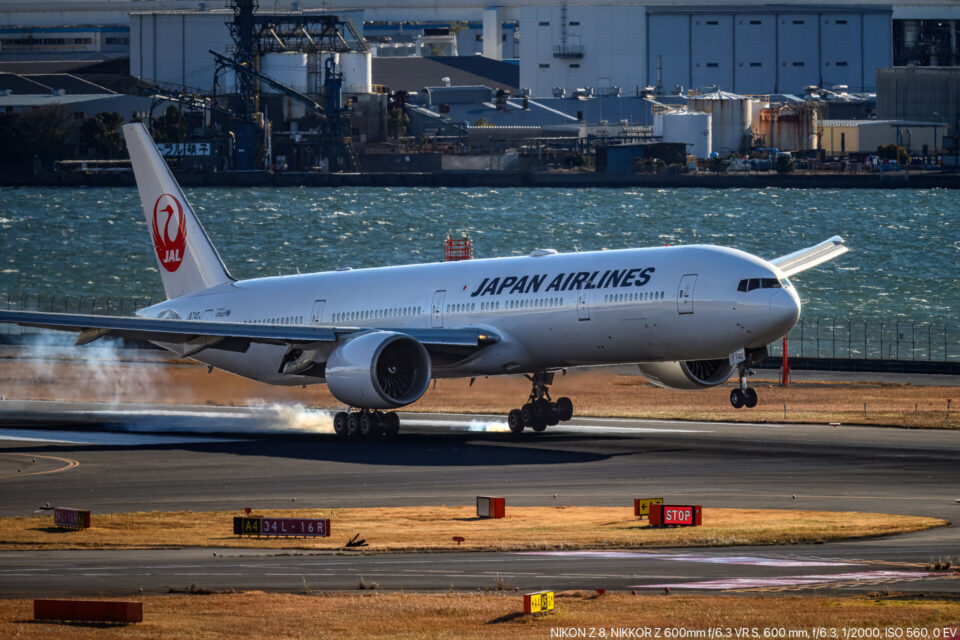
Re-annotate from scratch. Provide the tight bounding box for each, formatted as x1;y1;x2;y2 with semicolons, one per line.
0;188;960;321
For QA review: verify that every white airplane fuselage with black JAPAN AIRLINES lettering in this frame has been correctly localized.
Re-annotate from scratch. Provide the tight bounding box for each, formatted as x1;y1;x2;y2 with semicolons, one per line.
141;245;800;384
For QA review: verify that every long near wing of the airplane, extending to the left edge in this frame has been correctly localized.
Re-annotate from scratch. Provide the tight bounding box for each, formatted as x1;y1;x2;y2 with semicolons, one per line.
0;310;500;357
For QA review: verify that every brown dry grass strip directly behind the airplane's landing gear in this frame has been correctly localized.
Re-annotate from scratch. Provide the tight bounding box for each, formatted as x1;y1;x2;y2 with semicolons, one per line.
0;349;960;428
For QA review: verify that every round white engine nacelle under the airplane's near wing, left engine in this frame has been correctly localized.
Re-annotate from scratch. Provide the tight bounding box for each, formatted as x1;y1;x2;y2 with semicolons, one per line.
325;331;430;409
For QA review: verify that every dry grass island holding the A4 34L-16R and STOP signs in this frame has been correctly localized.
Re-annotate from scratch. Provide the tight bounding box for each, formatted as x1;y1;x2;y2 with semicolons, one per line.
0;504;948;552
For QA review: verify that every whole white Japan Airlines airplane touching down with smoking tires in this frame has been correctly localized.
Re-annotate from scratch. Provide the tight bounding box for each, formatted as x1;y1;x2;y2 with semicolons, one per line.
0;123;847;438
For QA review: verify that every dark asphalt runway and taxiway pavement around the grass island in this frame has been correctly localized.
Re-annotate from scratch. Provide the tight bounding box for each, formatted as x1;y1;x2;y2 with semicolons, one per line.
0;401;960;596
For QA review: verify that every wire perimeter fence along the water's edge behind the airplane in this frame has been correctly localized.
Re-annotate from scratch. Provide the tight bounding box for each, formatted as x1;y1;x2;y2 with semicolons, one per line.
0;293;960;362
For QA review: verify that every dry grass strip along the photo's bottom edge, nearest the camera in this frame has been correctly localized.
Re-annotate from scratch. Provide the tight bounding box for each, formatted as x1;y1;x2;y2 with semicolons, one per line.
0;591;960;640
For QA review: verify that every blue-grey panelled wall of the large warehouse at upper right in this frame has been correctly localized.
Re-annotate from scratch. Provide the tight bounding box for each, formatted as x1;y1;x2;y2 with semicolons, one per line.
647;7;891;93
